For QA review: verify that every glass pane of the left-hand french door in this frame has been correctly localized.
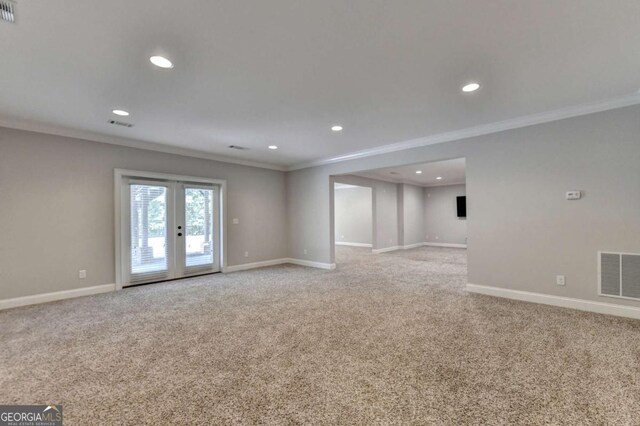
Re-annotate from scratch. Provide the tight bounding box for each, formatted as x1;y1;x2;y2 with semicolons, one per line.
131;185;167;275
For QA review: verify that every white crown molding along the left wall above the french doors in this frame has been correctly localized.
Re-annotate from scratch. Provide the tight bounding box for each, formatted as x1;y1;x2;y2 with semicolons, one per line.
0;117;287;172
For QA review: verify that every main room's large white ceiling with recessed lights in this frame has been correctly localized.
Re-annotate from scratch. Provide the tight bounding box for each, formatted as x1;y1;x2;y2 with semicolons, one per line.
0;0;640;167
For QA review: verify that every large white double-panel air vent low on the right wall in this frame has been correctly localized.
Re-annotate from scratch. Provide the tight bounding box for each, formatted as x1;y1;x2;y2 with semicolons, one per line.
598;252;640;300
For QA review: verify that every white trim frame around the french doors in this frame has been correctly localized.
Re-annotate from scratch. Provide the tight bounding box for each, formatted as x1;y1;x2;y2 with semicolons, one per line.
113;169;227;290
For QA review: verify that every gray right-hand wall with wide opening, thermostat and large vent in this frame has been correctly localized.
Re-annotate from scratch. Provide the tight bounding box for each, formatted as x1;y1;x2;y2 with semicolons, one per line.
287;106;640;306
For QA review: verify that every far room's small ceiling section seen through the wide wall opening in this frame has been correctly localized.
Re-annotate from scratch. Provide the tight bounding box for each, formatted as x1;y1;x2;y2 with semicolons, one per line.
351;158;466;186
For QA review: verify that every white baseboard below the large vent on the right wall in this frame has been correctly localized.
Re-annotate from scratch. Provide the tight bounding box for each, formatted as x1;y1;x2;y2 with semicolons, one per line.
467;284;640;319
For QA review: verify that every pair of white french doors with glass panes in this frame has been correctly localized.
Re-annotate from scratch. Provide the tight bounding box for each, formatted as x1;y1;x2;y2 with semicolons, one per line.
121;177;221;286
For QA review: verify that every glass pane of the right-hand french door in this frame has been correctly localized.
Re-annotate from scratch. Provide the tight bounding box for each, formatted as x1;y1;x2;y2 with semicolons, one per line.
184;188;215;268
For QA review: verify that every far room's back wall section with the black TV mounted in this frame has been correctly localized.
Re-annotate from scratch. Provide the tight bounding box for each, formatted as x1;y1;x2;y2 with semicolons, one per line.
424;185;467;244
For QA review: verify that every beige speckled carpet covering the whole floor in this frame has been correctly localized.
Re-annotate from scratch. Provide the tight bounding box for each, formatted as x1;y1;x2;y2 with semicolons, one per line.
0;247;640;425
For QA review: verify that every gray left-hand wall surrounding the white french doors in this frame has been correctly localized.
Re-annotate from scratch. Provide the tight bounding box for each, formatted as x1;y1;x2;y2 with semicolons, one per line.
0;128;284;299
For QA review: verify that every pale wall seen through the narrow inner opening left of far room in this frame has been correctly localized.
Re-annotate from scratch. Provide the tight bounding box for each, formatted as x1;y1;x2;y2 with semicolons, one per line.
335;186;373;244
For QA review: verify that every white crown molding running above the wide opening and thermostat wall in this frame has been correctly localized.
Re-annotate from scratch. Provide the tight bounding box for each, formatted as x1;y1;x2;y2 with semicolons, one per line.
287;93;640;171
